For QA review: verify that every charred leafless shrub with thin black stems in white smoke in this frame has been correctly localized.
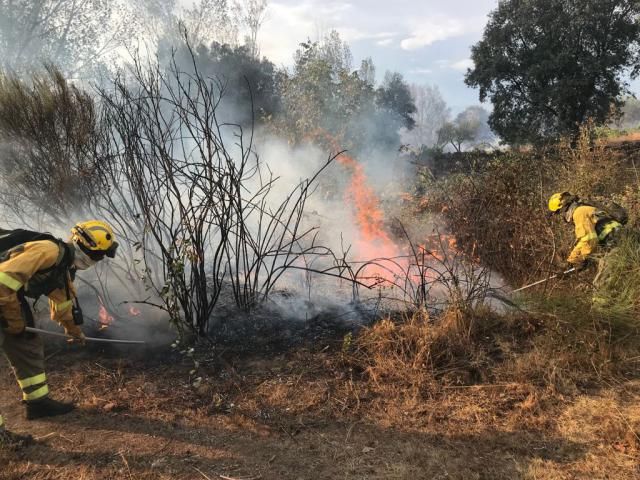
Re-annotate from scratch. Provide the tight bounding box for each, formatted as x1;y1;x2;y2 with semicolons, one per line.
97;47;342;336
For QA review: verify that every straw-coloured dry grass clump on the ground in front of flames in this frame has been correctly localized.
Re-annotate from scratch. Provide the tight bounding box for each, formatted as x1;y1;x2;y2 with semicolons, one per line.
348;308;507;400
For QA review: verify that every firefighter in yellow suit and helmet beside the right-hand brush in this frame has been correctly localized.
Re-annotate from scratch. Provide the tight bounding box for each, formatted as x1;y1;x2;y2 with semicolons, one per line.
549;192;622;272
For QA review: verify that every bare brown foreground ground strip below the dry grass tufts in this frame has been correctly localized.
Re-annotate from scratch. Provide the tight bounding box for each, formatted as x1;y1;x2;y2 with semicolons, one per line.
0;330;640;480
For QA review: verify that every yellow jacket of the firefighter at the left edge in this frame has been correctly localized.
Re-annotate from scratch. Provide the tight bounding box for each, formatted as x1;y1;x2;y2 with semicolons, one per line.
0;240;81;336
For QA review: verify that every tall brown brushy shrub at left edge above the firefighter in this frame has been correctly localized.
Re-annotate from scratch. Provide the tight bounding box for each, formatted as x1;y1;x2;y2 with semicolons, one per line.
0;65;103;221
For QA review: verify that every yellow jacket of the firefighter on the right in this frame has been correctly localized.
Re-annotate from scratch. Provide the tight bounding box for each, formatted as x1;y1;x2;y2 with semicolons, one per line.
567;205;622;265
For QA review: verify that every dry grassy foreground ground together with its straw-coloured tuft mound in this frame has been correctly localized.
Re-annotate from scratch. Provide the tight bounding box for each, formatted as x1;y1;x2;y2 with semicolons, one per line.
0;330;640;480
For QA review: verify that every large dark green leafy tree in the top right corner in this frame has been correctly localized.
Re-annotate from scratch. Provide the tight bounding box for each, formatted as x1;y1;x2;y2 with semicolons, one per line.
465;0;640;143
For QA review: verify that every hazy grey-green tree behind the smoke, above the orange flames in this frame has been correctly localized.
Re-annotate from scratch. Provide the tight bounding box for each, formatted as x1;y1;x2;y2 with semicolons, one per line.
276;31;415;154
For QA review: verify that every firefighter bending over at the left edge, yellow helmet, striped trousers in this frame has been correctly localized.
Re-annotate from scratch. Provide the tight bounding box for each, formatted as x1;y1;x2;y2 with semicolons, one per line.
0;220;118;442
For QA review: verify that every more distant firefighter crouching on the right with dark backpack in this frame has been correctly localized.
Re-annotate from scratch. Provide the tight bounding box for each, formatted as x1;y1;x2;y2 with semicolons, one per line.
549;192;628;286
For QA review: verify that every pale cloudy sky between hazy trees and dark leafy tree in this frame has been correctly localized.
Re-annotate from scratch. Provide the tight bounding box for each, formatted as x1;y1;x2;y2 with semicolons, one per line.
258;0;498;113
